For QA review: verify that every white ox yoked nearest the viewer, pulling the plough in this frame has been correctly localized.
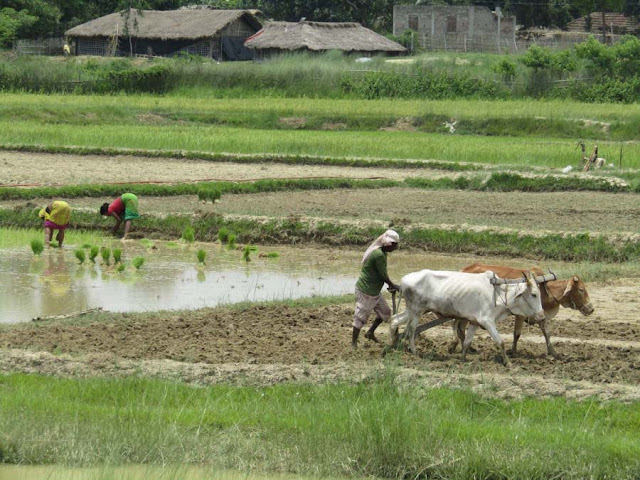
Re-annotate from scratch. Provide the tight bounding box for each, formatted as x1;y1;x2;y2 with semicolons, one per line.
390;270;544;365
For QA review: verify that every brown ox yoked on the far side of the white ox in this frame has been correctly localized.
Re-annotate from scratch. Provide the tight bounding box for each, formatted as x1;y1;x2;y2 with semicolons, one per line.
449;263;593;357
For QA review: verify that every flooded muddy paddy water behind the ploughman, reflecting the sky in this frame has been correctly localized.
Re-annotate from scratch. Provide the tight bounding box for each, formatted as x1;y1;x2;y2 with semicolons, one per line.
0;241;572;323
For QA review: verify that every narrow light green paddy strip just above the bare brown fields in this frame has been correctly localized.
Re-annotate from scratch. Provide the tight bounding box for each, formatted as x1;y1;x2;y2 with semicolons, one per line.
0;121;640;168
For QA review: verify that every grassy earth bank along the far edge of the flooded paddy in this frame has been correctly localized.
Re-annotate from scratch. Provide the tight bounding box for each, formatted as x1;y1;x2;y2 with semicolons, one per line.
5;209;640;262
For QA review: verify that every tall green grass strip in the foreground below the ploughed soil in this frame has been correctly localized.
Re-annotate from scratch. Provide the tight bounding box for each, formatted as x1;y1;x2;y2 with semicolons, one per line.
0;369;640;479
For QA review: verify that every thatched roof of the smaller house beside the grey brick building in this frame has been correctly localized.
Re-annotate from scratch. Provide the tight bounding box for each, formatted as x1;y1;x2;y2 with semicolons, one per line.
244;22;406;52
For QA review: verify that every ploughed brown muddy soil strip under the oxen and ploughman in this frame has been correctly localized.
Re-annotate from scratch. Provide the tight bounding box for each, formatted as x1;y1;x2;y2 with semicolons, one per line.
0;280;640;400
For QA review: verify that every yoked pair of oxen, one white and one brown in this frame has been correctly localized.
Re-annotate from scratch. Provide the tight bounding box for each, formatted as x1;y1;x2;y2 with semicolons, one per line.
390;263;594;365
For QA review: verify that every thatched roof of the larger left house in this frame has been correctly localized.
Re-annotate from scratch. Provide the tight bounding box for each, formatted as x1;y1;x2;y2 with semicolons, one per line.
64;9;262;40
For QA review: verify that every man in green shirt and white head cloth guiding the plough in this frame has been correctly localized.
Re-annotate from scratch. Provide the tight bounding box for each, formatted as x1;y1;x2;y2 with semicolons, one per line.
351;230;400;348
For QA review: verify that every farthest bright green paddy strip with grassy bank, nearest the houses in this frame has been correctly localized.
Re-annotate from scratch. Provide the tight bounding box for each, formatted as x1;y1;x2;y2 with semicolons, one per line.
0;93;640;140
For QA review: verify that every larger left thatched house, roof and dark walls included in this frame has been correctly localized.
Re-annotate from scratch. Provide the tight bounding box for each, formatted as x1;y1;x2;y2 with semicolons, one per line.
65;9;262;60
